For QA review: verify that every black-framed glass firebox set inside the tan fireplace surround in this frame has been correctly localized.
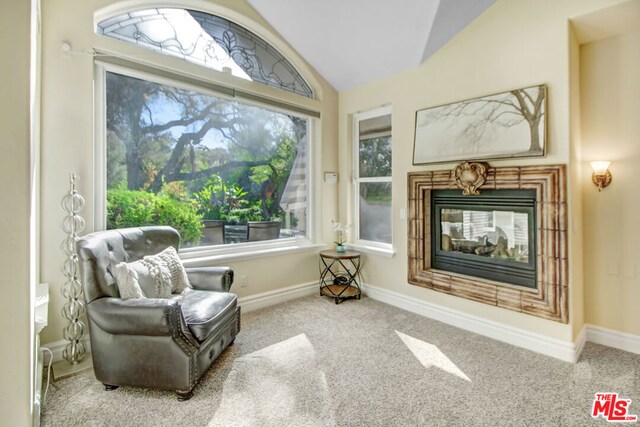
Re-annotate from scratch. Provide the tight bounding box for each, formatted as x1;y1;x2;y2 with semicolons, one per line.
431;190;537;288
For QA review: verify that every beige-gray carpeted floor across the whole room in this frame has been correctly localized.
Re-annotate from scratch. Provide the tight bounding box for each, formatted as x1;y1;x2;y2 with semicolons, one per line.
42;296;640;427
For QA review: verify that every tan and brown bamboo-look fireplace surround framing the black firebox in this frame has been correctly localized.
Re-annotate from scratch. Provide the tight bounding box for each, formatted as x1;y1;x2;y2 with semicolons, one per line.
408;165;569;323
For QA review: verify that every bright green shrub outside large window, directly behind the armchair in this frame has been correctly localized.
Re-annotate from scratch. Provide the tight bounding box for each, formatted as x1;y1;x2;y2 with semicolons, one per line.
107;187;202;246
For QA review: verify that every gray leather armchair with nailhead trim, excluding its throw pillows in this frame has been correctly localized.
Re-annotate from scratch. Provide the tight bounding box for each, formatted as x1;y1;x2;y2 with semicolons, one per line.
76;226;240;400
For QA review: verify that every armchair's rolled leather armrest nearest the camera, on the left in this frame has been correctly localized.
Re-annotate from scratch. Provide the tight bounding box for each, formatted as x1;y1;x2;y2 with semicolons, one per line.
87;298;194;340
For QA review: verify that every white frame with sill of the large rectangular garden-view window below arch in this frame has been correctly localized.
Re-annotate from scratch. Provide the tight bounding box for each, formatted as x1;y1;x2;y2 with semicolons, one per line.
94;58;324;266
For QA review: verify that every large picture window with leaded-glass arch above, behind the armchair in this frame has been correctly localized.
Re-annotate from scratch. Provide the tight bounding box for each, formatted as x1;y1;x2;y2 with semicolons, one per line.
96;8;319;251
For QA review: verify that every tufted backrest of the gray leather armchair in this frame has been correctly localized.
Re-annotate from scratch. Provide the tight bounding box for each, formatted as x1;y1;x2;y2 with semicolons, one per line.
76;226;180;304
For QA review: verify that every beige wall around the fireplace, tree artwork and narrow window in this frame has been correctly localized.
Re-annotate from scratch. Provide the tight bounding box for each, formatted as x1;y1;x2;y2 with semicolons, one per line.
339;0;628;341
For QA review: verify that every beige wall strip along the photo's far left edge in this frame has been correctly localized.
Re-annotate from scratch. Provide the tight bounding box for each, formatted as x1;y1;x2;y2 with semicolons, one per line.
0;1;33;426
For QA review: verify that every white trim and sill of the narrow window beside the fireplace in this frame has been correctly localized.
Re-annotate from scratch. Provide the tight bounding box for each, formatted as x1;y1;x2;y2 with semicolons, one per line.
347;105;396;257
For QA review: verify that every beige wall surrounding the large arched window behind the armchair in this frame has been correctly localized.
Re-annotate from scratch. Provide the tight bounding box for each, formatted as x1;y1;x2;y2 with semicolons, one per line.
41;0;337;343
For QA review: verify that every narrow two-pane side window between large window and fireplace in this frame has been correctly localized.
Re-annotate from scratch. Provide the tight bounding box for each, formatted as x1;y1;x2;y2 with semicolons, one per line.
354;107;392;246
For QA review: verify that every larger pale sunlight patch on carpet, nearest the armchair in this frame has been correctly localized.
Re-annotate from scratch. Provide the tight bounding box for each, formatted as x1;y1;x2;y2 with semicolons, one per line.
209;334;336;427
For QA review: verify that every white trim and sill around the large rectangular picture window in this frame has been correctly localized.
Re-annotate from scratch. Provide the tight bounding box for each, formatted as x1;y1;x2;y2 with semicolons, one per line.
93;61;326;267
